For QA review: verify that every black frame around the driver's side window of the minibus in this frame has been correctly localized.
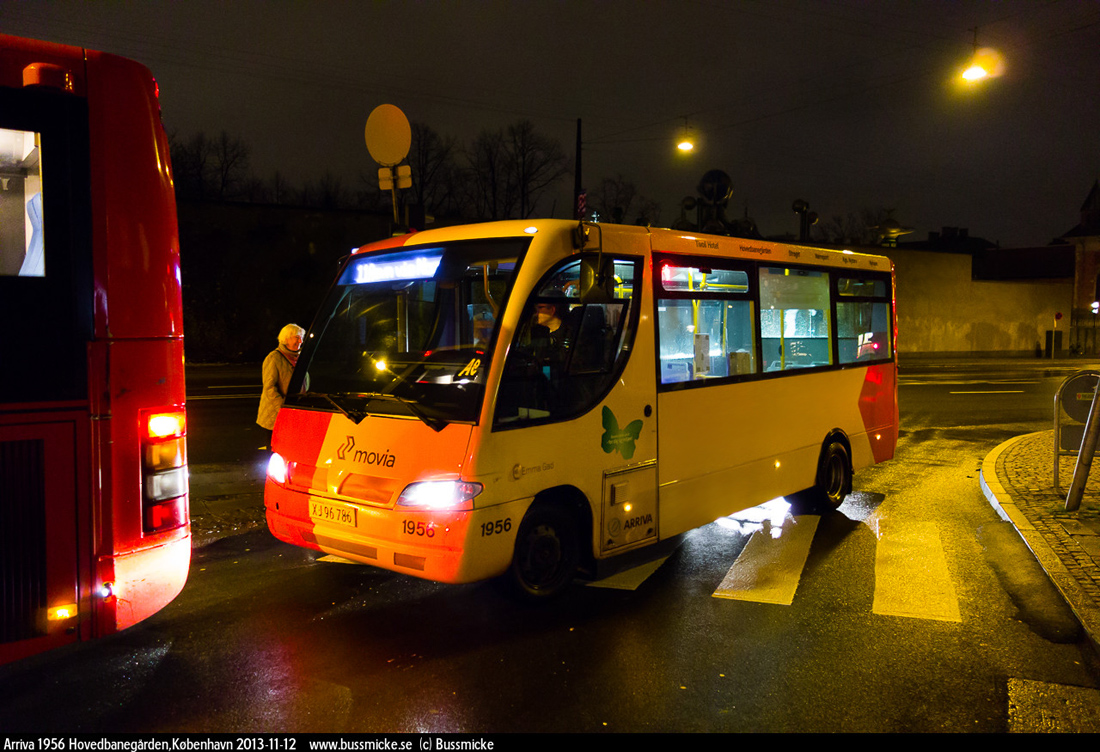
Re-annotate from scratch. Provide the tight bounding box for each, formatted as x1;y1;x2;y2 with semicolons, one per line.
490;252;646;432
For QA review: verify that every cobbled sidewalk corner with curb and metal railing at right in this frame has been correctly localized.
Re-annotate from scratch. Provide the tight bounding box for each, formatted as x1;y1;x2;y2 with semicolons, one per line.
981;429;1100;651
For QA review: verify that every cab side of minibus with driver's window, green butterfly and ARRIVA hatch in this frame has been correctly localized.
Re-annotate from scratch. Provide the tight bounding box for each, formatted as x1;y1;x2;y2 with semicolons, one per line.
494;254;658;556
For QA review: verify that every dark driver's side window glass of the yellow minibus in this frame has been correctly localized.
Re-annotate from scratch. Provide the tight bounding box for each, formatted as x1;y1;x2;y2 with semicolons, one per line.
494;261;634;425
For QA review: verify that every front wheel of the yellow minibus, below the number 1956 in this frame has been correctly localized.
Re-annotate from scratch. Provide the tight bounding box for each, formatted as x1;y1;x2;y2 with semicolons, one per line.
510;506;580;600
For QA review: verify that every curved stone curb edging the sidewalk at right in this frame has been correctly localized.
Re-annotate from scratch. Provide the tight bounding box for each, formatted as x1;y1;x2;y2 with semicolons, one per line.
979;431;1100;654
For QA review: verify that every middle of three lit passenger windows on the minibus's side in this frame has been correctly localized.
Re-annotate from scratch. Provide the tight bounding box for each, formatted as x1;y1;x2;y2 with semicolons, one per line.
760;267;833;372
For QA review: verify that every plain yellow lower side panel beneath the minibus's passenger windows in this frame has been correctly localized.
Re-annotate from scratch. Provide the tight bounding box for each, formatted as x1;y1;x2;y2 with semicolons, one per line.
658;368;872;539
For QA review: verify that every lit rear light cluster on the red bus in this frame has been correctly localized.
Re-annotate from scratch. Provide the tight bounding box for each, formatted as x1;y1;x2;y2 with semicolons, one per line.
142;409;187;533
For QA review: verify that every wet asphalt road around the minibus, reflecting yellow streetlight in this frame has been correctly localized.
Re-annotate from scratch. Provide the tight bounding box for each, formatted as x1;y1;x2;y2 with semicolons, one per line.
0;360;1100;732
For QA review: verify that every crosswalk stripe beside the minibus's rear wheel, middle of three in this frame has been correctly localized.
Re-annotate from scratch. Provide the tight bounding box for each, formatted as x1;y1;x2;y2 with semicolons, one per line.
712;515;821;606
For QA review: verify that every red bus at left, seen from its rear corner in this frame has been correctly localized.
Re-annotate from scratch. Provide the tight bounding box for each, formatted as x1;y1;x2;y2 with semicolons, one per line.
0;35;191;663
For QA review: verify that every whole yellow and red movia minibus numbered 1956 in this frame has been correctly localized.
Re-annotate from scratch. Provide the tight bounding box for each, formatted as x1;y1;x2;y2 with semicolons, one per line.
265;220;897;598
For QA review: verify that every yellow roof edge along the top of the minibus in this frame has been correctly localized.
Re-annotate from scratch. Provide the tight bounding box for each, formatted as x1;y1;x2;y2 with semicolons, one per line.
352;220;893;272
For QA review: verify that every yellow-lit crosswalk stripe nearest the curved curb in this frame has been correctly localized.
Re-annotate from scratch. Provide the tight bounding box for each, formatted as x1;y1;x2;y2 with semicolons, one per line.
871;518;963;622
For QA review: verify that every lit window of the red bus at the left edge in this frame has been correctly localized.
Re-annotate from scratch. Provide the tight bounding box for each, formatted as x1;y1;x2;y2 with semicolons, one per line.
0;128;46;277
